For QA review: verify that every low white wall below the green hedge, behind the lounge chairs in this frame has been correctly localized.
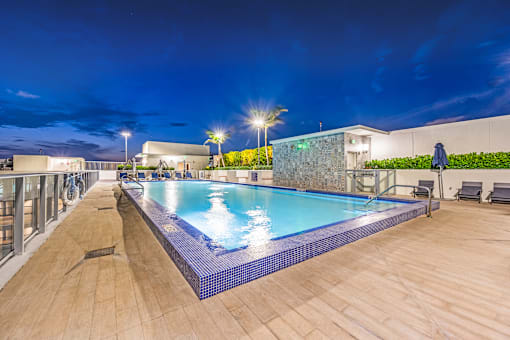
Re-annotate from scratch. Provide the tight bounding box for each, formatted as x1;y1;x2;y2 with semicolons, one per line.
396;169;510;200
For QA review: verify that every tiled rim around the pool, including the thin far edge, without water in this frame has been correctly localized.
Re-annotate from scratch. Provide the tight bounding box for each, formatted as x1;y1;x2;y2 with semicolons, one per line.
123;181;440;299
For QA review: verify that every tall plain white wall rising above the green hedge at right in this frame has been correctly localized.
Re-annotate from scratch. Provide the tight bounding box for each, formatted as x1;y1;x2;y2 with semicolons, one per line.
371;115;510;159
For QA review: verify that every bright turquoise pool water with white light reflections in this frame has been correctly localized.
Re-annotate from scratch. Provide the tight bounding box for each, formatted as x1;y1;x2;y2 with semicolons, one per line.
144;181;406;250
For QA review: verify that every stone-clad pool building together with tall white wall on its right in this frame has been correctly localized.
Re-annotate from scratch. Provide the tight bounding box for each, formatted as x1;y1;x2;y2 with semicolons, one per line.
271;115;510;191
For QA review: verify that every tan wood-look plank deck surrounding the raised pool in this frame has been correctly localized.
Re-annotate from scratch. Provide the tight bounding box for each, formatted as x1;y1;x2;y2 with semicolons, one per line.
0;182;510;339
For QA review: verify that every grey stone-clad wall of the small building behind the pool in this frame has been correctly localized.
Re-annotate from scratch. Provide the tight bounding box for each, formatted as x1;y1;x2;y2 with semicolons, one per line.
273;133;345;191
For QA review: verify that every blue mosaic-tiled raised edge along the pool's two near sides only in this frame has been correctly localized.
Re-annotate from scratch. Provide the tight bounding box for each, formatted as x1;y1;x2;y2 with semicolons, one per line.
124;182;439;299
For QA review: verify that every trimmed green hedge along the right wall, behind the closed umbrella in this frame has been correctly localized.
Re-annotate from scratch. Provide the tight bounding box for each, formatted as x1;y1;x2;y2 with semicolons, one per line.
365;152;510;169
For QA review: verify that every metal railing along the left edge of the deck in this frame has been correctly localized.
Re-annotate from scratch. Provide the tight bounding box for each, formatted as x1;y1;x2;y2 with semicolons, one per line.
0;171;99;265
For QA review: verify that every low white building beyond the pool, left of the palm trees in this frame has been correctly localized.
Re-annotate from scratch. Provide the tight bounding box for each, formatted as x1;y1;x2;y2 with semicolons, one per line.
136;141;210;171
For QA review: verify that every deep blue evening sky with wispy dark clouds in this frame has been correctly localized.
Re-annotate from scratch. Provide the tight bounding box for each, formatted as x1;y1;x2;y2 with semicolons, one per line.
0;0;510;161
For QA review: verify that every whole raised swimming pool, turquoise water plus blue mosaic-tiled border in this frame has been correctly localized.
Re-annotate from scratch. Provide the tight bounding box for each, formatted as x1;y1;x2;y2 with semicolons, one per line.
123;180;439;299
